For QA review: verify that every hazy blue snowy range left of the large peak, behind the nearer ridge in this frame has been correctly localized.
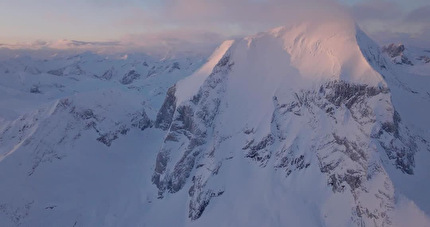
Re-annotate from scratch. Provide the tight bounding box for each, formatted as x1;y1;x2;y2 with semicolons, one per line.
0;52;205;120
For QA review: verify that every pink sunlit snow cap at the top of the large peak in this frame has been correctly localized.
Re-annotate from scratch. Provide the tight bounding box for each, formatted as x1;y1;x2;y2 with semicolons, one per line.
257;21;383;85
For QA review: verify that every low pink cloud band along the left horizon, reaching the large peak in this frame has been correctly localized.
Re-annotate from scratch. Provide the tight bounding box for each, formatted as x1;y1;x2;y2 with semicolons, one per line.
0;29;228;56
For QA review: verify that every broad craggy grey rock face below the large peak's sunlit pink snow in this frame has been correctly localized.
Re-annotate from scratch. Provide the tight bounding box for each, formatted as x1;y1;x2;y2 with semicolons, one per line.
272;82;417;226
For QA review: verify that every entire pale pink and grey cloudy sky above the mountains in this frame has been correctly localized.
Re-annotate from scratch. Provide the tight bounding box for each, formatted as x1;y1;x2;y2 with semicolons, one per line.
0;0;430;54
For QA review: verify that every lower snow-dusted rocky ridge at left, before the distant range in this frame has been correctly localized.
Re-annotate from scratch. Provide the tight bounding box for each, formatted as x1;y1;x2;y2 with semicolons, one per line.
0;92;153;176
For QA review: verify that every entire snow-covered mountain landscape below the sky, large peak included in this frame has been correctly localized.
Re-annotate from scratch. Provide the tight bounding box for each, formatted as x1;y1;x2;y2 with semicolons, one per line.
0;22;430;226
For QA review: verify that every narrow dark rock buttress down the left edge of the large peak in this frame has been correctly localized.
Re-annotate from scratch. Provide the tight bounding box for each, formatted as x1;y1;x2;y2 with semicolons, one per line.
152;52;234;219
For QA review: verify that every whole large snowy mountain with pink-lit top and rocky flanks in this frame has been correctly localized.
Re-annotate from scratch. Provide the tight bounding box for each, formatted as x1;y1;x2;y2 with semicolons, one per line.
152;20;428;226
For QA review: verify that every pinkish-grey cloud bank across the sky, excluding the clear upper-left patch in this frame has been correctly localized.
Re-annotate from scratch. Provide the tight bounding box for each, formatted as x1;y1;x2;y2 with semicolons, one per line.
0;0;430;54
